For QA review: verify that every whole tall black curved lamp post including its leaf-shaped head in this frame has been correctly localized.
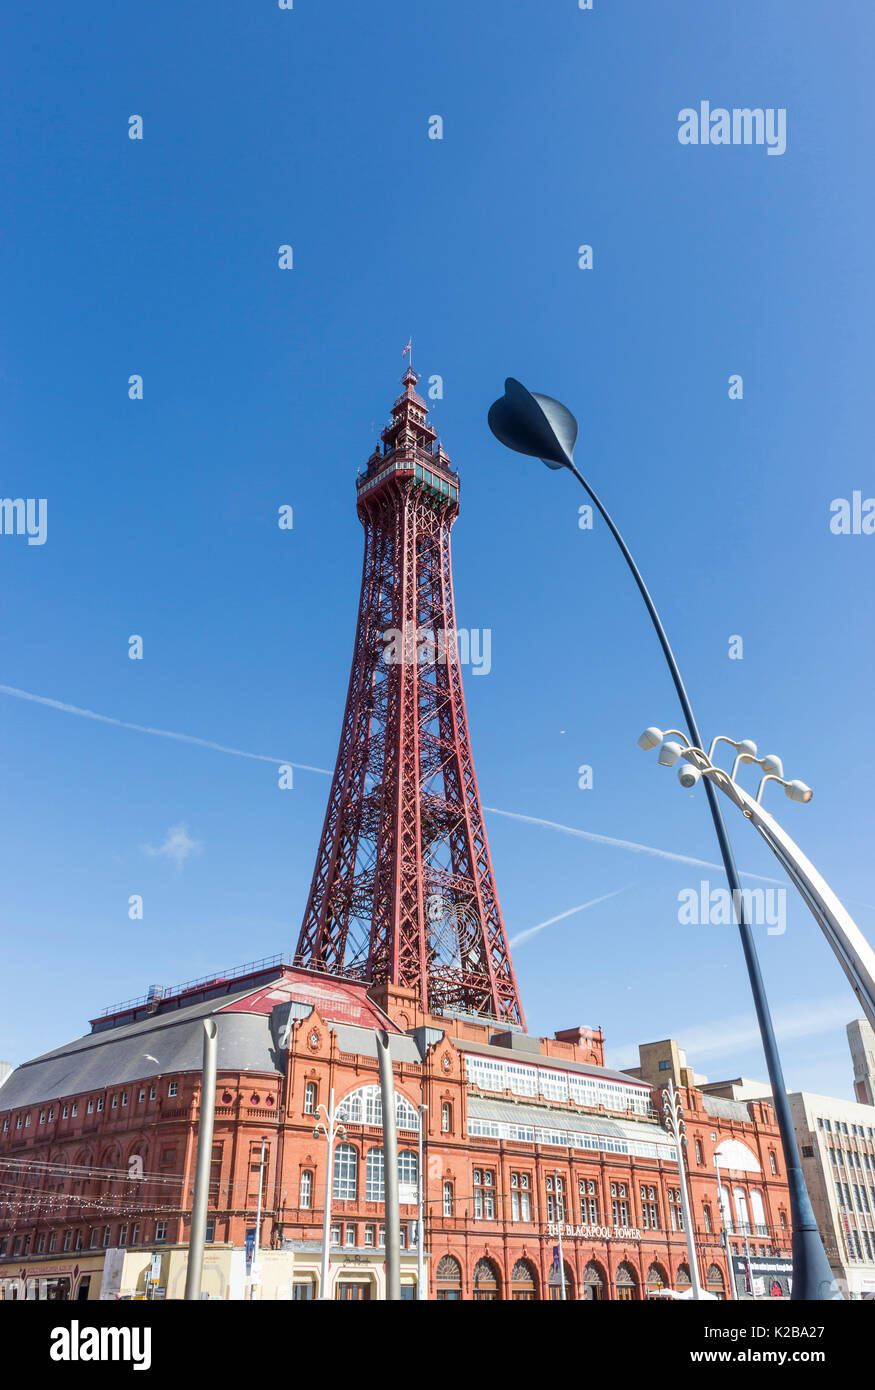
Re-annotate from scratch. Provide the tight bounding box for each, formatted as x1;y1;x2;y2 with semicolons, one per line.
488;377;840;1300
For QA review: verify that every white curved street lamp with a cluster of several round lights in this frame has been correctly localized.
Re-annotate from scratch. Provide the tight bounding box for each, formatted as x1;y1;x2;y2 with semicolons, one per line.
639;727;875;1027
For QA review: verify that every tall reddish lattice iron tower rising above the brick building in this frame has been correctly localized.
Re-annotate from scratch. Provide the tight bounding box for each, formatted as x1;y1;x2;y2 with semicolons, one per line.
295;368;524;1026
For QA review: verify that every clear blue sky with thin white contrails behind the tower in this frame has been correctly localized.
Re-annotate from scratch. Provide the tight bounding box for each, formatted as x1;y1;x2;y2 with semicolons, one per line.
0;0;875;1095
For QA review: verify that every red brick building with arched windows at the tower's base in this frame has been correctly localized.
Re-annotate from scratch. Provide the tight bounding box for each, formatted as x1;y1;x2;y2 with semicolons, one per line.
0;962;790;1300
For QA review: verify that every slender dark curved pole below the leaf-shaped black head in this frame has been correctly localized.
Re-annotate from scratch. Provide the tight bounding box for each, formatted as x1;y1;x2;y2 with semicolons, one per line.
568;460;842;1301
